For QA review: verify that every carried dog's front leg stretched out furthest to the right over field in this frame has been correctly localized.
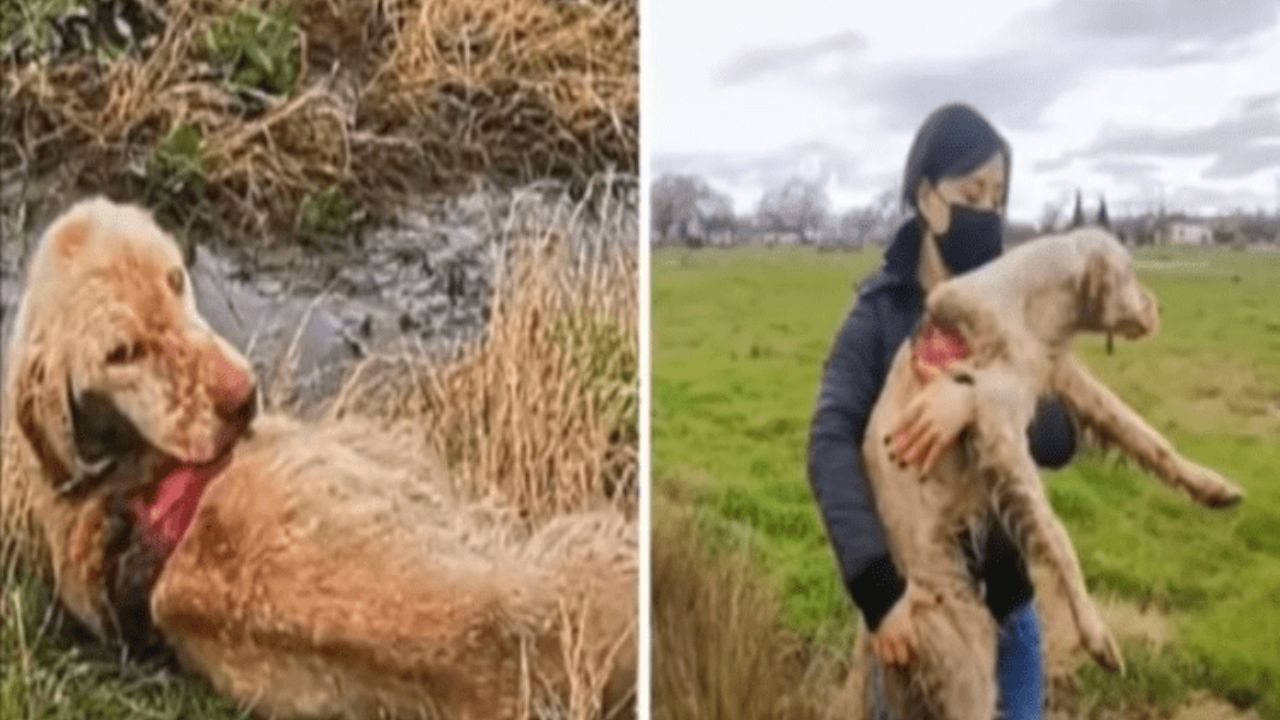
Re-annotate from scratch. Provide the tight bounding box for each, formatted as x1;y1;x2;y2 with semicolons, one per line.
1053;356;1244;507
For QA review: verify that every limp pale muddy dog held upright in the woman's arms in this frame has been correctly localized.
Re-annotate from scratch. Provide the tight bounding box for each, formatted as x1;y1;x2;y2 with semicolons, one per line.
859;229;1242;720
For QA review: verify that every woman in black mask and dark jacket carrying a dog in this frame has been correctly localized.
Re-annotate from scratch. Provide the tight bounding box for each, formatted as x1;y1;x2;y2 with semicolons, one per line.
809;105;1075;720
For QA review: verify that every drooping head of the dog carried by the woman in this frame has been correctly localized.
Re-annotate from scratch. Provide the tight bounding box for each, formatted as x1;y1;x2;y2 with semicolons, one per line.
1075;228;1160;340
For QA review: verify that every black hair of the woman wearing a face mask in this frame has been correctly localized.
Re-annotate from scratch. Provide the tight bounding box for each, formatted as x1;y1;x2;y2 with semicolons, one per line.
902;102;1012;208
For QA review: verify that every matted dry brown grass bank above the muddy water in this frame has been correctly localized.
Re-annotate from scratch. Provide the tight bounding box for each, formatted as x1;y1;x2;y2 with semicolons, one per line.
0;0;639;237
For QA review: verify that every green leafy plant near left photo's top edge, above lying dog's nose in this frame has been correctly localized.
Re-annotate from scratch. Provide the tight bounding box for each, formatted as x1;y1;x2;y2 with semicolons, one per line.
206;8;300;95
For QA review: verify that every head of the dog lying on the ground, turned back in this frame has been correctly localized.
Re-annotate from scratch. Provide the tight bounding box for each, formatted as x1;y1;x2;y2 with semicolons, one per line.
6;199;256;493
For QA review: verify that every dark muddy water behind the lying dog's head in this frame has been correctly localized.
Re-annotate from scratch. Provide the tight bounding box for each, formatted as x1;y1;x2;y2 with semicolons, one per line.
0;178;636;407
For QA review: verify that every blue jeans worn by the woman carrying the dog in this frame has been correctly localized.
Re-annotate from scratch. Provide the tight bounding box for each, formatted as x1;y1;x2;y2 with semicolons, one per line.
867;602;1044;720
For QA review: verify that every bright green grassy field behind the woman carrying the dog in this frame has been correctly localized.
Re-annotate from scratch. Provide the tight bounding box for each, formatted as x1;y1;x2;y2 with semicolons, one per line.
652;243;1280;717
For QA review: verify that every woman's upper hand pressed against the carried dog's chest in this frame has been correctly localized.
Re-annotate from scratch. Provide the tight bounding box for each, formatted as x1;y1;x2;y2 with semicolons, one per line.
891;377;973;473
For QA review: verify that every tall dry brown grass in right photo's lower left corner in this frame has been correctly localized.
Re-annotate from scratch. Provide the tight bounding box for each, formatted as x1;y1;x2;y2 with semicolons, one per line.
652;503;851;720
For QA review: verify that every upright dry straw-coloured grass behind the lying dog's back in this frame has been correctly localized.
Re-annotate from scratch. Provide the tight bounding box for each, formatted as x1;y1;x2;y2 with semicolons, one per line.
332;198;639;523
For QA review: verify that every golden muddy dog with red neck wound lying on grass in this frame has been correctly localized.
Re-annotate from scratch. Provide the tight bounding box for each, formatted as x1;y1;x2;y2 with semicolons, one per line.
0;200;636;719
